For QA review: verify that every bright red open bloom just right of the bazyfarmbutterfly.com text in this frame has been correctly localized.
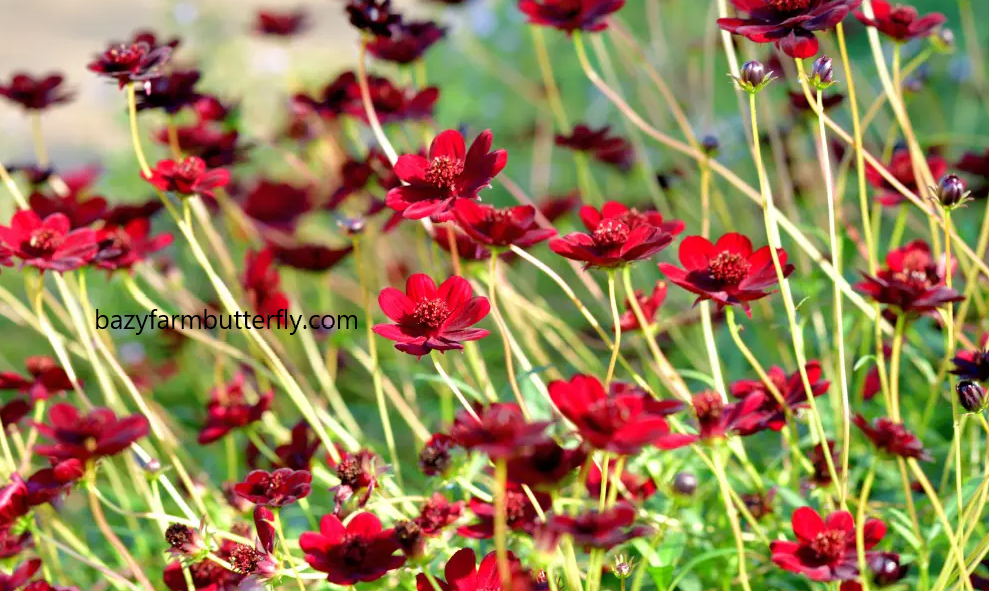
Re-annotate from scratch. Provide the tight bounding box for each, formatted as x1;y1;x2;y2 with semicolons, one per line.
374;273;490;357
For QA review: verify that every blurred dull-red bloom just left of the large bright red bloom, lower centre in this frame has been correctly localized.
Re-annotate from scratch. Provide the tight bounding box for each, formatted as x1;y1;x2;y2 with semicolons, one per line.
450;402;550;458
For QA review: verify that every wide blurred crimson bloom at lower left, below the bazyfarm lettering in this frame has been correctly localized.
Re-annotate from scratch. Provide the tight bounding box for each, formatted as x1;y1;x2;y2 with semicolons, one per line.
35;403;149;464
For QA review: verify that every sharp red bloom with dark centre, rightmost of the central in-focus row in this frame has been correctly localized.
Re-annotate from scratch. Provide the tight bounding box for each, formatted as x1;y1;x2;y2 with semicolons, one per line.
659;233;794;315
